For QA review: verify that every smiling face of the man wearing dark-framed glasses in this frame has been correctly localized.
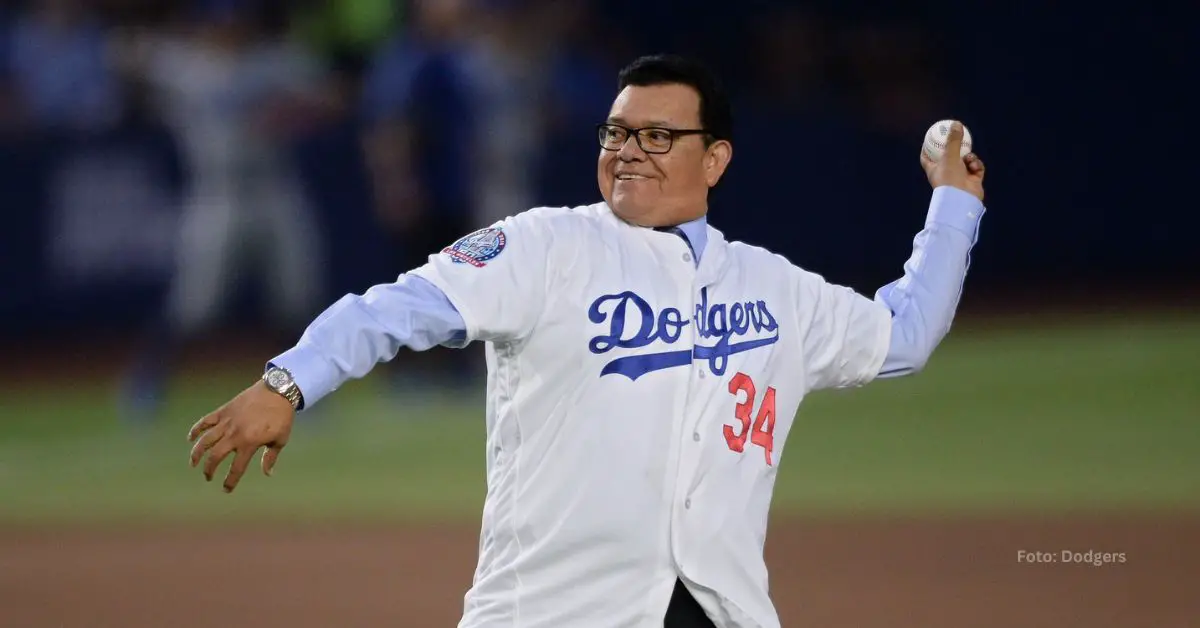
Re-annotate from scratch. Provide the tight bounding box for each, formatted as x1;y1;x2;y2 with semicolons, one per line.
596;84;731;227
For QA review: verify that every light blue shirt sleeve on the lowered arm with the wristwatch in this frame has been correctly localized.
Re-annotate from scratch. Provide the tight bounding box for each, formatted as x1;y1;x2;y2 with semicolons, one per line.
270;275;467;408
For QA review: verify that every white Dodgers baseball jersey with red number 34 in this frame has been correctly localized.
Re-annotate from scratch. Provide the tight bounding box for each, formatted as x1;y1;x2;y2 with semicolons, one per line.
413;203;892;628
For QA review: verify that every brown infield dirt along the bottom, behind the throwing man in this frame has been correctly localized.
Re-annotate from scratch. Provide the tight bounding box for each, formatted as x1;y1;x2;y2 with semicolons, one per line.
0;515;1200;628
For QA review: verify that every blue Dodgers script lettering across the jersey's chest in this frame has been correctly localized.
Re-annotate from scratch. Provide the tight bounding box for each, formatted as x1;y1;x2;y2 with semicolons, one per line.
588;288;779;379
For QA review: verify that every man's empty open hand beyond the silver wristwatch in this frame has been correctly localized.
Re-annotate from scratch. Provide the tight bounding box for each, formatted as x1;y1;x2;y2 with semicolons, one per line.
187;382;295;492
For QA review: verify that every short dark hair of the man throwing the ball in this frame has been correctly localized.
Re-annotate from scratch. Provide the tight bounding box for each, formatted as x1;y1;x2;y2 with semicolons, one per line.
617;54;733;144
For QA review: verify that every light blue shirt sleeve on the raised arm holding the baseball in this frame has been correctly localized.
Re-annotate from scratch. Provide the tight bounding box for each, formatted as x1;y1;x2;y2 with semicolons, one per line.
875;186;984;377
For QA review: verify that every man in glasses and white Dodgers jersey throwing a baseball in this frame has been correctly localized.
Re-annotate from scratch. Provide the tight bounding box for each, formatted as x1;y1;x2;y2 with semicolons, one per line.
188;56;984;627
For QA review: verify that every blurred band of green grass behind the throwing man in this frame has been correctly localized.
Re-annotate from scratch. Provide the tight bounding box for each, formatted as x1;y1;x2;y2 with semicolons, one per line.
0;318;1200;522
